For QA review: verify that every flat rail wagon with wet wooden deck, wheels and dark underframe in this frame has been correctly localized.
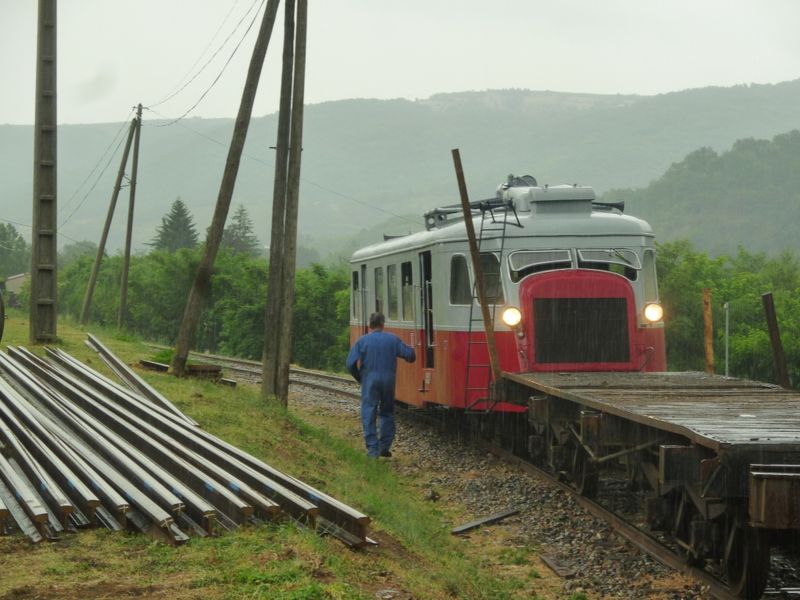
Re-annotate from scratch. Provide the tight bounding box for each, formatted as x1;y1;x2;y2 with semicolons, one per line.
494;372;800;599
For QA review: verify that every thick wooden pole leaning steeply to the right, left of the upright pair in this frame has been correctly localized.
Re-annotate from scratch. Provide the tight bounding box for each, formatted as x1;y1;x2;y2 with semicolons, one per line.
171;0;278;375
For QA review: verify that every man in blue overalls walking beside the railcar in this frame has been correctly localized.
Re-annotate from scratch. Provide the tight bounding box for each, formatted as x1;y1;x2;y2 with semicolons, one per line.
347;312;417;458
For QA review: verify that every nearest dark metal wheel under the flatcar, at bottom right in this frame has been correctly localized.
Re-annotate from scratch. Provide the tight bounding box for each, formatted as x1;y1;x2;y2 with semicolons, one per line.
725;524;769;600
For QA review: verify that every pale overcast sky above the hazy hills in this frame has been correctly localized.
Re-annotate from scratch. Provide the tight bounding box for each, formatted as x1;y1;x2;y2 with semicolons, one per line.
0;0;800;124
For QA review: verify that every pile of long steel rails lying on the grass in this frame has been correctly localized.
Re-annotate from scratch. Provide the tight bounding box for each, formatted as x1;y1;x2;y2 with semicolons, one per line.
0;336;371;546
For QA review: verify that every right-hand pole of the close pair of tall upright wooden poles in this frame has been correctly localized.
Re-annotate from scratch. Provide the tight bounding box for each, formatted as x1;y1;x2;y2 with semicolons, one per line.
276;0;308;406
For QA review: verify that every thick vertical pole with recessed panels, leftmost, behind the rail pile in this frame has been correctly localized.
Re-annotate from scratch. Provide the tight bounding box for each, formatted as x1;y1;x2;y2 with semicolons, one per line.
29;0;58;344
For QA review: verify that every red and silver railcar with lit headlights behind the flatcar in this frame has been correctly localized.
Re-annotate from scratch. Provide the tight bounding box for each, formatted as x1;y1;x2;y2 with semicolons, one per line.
350;176;666;412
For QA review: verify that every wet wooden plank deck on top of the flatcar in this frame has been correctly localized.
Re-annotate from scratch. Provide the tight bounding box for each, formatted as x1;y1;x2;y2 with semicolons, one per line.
503;372;800;450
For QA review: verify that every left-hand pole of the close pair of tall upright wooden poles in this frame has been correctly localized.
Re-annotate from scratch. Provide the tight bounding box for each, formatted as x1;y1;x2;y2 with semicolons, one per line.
261;0;295;401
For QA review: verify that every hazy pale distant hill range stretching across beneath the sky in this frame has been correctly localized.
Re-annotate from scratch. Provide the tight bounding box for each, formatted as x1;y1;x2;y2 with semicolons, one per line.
0;80;800;255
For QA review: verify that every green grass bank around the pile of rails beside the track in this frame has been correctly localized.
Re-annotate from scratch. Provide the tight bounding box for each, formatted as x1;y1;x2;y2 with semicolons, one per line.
0;311;560;600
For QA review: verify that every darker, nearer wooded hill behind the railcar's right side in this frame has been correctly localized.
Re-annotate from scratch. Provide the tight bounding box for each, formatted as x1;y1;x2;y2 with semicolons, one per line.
605;130;800;255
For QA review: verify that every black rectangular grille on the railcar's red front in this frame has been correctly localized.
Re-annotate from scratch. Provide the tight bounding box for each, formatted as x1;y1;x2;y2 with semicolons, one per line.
533;298;630;364
